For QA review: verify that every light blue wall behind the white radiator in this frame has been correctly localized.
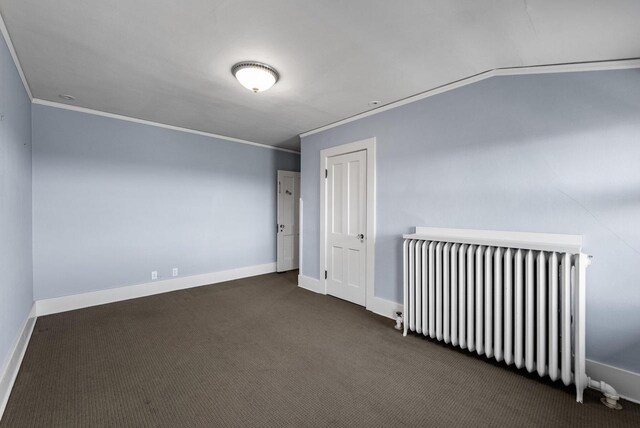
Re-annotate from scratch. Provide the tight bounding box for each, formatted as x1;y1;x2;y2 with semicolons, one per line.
301;69;640;372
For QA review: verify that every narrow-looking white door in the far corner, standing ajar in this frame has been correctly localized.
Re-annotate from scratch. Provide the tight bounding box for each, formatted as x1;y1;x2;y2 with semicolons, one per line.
276;171;300;272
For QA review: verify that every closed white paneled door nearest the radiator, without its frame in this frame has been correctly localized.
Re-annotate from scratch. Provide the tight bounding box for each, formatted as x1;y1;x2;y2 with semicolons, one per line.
325;150;367;306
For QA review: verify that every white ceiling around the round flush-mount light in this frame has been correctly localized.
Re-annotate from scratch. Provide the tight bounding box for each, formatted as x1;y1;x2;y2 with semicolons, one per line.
0;0;640;148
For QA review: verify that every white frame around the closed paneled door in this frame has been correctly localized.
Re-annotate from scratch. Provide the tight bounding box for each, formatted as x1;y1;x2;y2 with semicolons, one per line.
320;137;376;310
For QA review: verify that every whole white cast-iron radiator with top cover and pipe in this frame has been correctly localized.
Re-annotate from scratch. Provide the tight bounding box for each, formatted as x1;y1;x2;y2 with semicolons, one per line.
403;227;619;407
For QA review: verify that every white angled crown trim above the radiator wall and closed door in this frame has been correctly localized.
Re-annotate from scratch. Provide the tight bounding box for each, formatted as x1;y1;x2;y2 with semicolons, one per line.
300;58;640;138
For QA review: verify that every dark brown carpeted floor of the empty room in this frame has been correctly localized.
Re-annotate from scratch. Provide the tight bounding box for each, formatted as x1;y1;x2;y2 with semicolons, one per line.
0;272;640;427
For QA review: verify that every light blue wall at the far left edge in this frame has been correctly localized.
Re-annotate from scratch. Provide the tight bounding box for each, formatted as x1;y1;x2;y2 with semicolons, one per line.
0;37;33;375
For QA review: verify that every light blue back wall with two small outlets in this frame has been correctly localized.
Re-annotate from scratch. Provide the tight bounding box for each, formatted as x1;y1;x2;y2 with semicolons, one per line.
33;105;300;299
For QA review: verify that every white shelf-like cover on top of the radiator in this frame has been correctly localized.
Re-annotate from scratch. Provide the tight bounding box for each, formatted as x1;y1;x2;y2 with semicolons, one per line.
402;227;582;254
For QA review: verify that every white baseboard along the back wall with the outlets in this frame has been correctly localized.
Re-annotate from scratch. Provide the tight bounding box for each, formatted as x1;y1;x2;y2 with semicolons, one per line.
36;263;276;317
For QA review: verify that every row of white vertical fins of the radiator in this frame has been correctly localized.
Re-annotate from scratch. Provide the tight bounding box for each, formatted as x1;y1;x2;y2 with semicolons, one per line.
403;239;575;385
